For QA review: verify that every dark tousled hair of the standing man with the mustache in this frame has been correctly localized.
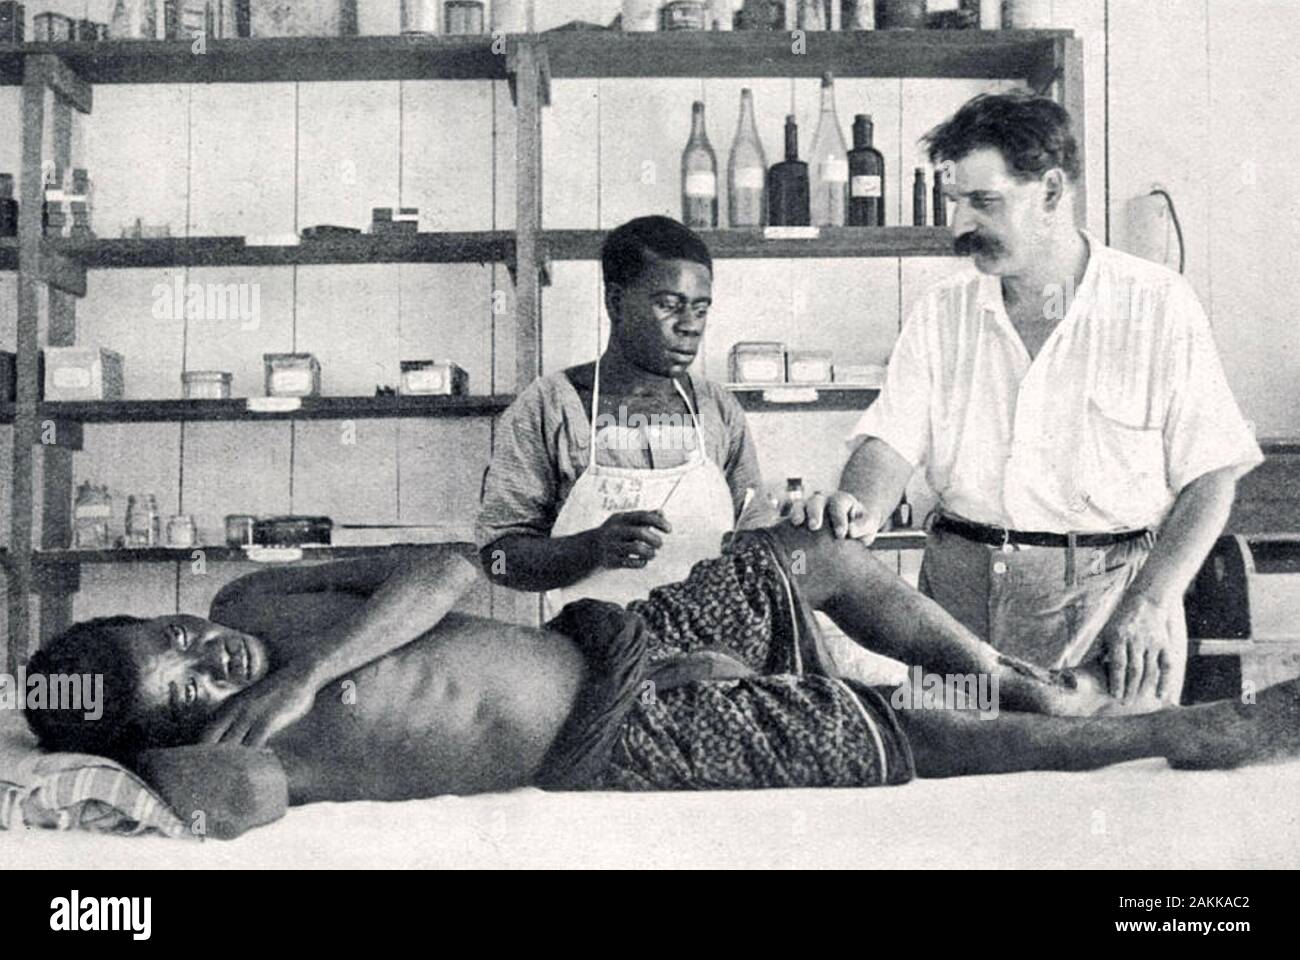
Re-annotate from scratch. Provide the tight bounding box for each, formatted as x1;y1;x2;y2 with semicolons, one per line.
922;91;1079;181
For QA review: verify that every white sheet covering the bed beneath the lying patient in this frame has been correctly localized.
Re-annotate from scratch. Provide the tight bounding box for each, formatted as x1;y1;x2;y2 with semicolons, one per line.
0;761;1300;869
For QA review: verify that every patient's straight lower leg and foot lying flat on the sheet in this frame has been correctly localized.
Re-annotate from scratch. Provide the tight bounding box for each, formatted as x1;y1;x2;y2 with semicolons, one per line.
897;680;1300;777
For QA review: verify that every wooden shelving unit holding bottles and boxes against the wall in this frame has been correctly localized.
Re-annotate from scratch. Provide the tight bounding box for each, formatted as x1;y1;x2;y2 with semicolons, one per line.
0;30;1086;667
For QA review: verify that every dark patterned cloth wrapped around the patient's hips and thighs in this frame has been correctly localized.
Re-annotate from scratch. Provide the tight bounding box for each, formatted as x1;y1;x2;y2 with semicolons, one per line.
536;531;915;790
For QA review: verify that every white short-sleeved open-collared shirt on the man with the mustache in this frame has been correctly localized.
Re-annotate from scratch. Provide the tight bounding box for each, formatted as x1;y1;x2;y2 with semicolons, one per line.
850;233;1264;533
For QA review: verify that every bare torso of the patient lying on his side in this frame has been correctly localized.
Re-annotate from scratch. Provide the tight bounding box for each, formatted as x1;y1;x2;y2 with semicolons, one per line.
270;614;584;804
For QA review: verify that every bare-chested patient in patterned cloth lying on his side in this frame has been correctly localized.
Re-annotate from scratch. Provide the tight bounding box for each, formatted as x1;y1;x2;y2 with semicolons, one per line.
20;526;1300;836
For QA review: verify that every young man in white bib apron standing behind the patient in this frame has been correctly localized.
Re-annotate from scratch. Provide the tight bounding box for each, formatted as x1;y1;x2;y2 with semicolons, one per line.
477;217;774;618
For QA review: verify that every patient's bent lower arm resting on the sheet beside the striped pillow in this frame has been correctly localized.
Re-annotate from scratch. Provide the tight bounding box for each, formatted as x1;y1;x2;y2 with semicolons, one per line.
134;744;290;840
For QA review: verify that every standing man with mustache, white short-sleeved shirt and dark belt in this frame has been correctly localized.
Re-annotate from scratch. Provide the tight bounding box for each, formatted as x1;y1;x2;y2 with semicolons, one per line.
793;94;1262;701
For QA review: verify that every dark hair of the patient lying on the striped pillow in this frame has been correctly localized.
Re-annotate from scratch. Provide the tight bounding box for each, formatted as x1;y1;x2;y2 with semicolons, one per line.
18;617;150;760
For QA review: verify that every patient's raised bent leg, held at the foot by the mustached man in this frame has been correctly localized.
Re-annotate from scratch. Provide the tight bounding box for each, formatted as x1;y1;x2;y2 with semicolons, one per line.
774;524;1158;715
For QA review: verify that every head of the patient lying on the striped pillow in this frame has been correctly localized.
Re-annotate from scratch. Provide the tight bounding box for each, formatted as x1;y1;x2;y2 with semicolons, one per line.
26;617;267;757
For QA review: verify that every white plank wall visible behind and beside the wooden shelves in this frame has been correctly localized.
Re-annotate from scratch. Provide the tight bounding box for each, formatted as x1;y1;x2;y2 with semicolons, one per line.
0;0;1300;640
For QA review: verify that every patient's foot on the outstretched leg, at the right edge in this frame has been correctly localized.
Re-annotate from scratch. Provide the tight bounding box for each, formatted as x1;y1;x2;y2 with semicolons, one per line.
1169;680;1300;770
